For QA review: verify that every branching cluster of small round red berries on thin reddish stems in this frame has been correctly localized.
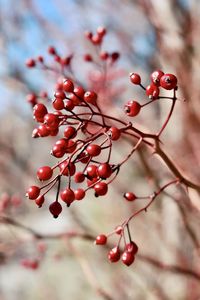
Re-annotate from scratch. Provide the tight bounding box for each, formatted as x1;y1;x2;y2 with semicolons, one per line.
26;27;177;265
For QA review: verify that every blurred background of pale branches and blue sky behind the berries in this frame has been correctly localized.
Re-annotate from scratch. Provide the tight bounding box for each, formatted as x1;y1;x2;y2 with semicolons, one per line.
0;0;200;300
